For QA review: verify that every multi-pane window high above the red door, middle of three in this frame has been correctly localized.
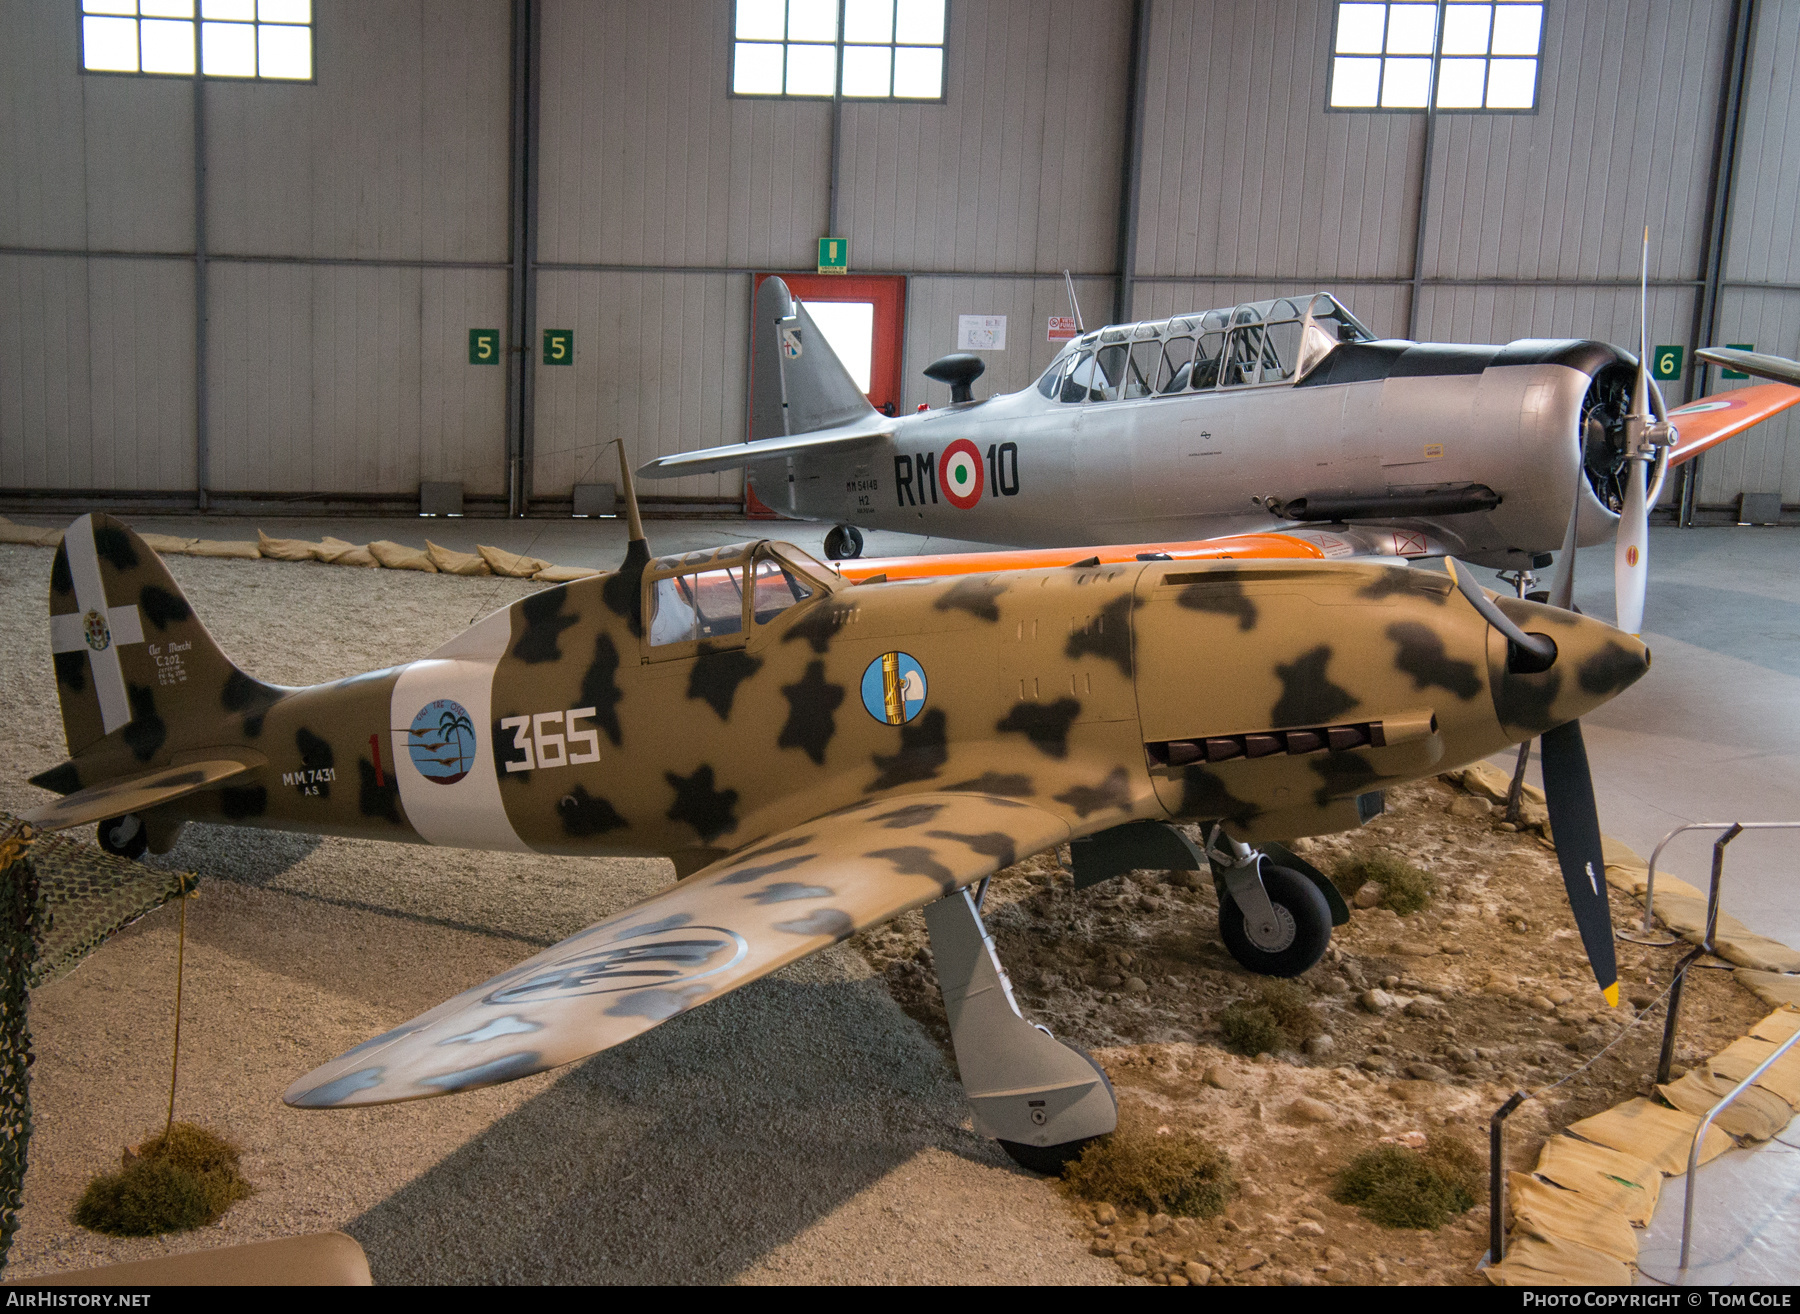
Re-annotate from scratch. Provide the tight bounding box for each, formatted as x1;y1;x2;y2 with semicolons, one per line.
731;0;947;101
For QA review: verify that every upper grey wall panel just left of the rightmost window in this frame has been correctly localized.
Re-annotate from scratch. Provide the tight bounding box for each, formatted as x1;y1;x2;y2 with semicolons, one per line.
1138;0;1424;277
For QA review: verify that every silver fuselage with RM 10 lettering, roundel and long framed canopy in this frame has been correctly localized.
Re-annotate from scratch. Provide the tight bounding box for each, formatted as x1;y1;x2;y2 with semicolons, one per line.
745;293;1629;565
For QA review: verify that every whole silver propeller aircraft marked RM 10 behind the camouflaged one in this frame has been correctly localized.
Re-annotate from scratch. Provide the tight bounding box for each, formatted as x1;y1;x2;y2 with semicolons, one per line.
639;270;1800;632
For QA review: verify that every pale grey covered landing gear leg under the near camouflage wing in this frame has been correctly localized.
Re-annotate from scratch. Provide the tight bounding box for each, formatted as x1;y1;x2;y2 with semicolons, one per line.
925;889;1118;1174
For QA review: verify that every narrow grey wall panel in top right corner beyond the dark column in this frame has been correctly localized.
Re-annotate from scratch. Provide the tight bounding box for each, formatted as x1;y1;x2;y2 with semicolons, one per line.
1726;0;1800;286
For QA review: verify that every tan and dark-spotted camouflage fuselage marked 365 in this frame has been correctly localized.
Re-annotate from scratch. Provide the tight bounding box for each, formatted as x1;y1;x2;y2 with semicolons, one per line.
151;544;1645;853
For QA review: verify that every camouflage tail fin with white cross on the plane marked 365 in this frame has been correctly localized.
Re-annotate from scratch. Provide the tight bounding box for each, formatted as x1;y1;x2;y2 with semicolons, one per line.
36;513;284;774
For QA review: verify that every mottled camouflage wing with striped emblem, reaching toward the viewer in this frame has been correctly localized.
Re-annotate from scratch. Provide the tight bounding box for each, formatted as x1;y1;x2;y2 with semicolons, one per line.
283;794;1069;1109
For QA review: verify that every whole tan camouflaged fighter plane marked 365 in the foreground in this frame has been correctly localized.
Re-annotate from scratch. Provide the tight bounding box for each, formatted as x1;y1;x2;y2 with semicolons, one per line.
27;473;1649;1170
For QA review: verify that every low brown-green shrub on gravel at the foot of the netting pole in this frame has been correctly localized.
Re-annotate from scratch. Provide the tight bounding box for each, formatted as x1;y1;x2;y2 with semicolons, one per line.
74;1123;252;1237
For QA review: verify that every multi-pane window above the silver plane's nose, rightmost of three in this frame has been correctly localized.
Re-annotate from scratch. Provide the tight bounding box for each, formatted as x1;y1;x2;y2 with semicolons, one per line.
1327;0;1544;112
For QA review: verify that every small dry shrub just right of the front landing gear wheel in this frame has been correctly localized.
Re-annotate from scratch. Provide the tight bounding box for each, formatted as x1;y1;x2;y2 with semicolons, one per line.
1062;1109;1237;1219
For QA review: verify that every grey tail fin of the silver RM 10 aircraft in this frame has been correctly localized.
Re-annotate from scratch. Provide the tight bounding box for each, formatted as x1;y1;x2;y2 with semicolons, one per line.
751;277;880;441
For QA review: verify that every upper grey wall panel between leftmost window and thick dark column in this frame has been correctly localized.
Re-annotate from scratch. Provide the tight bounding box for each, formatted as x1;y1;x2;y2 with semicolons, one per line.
207;0;511;261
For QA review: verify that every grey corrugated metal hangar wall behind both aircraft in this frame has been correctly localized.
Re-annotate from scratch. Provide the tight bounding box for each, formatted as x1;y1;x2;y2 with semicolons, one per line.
0;0;1800;511
